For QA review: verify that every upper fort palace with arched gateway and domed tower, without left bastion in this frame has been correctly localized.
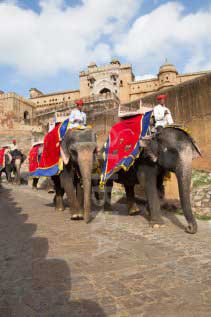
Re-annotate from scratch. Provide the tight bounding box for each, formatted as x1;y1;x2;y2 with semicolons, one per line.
30;59;209;109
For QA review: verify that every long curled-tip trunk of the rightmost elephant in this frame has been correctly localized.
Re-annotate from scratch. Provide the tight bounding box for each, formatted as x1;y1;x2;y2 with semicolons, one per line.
176;162;197;233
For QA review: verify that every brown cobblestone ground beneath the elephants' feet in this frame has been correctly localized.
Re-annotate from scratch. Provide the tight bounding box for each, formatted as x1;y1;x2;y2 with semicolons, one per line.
0;184;211;317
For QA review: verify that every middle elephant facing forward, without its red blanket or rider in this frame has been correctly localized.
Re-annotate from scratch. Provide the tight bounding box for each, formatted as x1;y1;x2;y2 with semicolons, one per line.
52;128;97;223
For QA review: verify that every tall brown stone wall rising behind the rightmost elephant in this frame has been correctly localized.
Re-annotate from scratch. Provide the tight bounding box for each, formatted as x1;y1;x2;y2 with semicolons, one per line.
134;73;211;170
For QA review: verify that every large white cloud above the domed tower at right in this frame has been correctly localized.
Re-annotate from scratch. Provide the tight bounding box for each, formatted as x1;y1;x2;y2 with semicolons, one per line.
115;1;211;72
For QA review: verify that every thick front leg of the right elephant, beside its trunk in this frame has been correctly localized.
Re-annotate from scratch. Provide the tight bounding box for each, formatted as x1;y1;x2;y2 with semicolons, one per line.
138;166;164;226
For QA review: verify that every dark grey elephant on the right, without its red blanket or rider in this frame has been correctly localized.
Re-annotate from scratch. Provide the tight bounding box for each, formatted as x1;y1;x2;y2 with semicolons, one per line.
101;126;201;234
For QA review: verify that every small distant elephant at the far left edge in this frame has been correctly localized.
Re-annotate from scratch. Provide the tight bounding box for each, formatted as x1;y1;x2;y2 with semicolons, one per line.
0;150;26;185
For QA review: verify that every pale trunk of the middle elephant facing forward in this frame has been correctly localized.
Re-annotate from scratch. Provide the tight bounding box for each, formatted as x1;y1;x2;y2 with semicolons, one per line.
78;148;93;223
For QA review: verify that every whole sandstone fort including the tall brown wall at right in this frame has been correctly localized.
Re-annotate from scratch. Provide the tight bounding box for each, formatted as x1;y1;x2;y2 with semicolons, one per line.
0;60;211;174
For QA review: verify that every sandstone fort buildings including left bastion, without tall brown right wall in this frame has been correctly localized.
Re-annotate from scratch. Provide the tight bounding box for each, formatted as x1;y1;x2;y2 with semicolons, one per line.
0;59;209;128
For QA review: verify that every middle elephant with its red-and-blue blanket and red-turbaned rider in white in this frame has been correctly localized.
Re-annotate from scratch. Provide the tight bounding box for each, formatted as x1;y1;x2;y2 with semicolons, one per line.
31;100;97;222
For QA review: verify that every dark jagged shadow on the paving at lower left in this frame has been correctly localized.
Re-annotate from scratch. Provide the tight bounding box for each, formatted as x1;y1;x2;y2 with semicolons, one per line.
0;187;105;317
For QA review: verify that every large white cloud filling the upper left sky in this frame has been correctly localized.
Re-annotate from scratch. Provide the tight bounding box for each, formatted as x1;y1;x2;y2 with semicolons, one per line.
0;0;140;76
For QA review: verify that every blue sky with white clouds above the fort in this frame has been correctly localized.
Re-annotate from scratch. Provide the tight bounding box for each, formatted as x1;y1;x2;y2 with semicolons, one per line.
0;0;211;96
